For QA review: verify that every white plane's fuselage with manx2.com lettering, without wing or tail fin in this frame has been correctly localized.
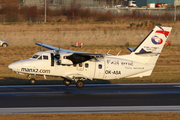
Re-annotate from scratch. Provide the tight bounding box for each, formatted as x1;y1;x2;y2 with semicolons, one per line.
9;51;154;80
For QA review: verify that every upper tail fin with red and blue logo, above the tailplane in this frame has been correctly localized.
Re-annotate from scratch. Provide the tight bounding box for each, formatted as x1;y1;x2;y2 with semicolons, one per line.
133;26;172;54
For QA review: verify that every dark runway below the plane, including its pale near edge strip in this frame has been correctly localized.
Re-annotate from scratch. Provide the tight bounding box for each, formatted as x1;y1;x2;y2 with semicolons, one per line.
0;83;180;114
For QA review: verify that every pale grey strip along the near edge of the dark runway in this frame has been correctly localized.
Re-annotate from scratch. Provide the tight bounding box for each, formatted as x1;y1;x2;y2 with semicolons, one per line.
0;106;180;114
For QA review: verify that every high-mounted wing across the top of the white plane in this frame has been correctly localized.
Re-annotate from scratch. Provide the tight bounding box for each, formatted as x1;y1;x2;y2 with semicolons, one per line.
36;43;104;63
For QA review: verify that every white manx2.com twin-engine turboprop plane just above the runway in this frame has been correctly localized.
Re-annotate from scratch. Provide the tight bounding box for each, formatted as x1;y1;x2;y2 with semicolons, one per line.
8;26;172;88
